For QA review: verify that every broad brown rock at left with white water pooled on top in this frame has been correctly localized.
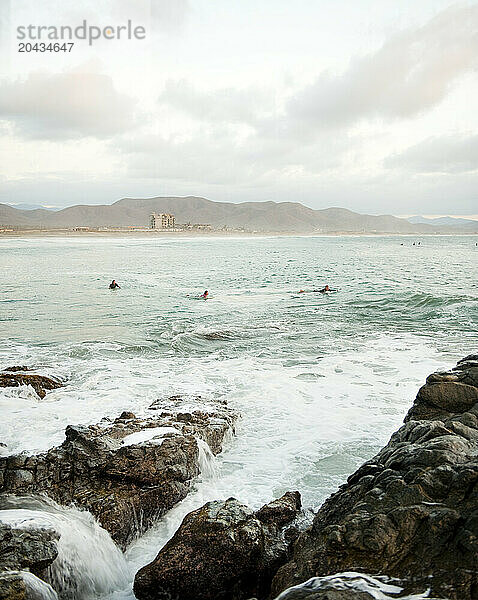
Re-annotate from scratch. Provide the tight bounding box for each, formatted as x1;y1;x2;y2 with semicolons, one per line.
0;407;235;548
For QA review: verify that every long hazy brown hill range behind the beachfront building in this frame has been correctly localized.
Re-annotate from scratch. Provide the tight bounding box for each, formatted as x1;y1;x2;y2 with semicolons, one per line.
0;196;470;233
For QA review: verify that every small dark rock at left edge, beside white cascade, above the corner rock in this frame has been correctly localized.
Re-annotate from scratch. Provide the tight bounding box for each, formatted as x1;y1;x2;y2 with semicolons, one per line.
0;523;60;575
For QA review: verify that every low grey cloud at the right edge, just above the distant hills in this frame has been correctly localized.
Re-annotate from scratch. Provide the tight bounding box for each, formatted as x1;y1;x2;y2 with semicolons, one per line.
384;135;478;174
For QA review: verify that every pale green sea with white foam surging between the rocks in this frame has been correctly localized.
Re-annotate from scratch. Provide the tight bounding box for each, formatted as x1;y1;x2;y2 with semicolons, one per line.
0;236;478;599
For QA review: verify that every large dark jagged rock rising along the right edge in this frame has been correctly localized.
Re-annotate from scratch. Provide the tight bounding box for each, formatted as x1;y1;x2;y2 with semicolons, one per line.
272;355;478;600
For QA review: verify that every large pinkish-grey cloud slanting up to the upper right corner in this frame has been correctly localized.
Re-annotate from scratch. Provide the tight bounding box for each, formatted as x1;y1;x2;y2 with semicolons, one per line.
285;5;478;137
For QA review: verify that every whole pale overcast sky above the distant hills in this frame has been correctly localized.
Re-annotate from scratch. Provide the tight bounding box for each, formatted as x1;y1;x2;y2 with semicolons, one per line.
0;0;478;215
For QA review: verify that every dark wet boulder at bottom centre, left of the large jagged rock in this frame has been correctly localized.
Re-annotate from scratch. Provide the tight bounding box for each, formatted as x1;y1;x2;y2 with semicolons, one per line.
134;492;300;600
